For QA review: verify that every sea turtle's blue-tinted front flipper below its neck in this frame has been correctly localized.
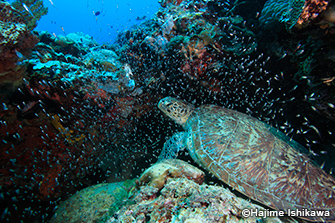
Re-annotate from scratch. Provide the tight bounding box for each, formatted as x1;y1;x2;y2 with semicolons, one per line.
158;132;186;161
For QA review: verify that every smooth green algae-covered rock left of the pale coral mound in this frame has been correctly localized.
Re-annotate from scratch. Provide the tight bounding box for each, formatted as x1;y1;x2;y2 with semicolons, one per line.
50;180;135;223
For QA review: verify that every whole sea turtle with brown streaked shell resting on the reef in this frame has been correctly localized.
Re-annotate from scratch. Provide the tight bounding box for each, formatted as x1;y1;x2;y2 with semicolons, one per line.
158;97;335;221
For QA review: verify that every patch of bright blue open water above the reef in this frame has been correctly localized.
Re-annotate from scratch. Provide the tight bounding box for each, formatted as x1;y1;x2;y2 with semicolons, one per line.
9;0;159;44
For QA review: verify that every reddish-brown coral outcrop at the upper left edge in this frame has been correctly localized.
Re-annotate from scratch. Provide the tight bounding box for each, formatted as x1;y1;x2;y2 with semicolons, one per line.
0;2;38;99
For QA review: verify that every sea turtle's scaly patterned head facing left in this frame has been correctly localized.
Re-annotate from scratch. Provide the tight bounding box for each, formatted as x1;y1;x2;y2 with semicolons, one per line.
158;97;195;126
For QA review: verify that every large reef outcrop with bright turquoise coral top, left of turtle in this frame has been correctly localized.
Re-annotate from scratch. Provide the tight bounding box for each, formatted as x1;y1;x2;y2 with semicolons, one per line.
0;27;158;216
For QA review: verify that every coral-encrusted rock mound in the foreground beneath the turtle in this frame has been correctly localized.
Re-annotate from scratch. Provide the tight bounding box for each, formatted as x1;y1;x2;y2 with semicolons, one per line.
50;159;282;223
